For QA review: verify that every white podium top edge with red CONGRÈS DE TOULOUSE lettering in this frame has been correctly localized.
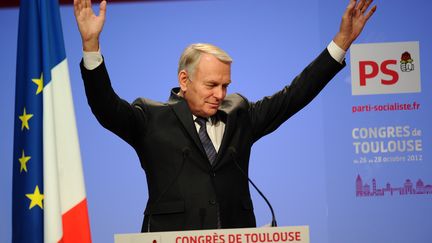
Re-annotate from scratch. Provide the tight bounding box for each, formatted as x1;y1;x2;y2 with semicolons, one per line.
114;226;309;243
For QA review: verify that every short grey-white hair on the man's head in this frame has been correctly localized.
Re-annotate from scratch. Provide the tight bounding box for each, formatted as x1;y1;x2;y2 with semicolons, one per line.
177;43;232;76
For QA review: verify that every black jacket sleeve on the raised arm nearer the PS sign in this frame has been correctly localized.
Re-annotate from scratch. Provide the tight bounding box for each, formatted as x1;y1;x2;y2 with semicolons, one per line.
249;48;345;141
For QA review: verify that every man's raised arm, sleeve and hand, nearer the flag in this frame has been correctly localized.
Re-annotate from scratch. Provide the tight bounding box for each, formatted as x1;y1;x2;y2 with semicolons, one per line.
74;0;145;145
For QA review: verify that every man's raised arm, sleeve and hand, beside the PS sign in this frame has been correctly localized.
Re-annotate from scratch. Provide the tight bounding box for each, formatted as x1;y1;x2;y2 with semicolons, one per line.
250;0;376;139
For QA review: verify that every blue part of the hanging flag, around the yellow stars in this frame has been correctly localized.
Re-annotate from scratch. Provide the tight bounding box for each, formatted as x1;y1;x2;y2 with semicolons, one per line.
12;0;66;242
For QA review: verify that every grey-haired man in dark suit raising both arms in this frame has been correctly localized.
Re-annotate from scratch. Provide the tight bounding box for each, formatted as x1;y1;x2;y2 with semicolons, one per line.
74;0;376;232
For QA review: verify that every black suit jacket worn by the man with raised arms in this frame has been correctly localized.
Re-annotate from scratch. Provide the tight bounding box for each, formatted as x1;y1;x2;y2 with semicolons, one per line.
81;49;344;231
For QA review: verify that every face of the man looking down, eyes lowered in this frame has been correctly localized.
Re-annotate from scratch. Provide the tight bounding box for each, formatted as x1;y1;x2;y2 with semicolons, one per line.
179;53;231;117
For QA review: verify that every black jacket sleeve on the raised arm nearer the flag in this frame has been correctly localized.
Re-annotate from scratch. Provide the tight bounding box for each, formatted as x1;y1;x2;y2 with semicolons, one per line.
80;58;146;146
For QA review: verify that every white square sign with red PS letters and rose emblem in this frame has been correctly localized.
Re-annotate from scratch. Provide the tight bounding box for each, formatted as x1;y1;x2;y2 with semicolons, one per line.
351;42;421;95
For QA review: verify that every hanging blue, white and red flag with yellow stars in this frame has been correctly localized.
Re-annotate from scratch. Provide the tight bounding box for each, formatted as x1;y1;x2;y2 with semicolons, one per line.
12;0;91;243
